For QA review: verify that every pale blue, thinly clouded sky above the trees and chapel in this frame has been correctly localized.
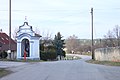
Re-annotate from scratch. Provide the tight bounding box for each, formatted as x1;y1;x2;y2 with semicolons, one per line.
0;0;120;39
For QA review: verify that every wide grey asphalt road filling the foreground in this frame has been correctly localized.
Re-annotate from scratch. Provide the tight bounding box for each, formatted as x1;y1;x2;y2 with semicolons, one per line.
0;56;120;80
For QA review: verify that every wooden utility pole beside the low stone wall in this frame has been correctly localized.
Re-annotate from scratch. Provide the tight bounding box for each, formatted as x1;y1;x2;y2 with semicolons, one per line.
91;8;95;59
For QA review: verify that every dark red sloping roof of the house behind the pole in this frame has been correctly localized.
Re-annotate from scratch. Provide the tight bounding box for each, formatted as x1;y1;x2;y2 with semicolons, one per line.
0;32;17;50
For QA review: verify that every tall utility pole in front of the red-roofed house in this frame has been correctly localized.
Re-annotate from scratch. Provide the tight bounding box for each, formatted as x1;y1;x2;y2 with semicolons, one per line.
8;0;11;59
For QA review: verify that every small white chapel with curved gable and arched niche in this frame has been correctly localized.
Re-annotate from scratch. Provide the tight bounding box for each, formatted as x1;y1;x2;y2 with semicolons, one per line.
16;21;41;60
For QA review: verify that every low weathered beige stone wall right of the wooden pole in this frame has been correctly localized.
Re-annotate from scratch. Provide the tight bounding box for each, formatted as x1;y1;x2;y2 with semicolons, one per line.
95;47;120;62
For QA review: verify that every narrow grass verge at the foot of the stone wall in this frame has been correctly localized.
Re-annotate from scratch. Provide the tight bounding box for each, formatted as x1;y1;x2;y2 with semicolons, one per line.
86;59;120;66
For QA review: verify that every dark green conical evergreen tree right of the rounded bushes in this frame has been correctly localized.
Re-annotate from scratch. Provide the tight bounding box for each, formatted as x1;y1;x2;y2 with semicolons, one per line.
53;32;65;59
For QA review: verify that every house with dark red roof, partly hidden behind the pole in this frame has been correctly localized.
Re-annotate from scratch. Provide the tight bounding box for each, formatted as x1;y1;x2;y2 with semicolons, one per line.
0;30;17;59
